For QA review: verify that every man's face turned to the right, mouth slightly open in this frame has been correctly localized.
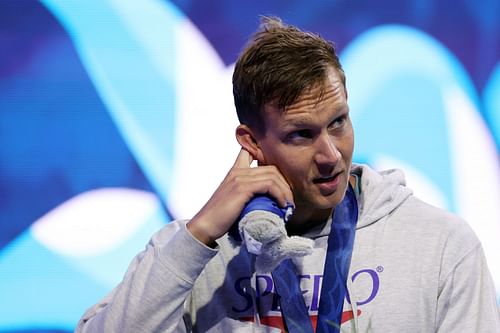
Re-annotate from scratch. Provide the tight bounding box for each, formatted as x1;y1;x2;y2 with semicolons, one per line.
257;69;354;219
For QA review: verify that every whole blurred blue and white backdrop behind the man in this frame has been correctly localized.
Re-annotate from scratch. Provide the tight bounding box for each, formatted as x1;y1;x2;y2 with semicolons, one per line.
0;0;500;332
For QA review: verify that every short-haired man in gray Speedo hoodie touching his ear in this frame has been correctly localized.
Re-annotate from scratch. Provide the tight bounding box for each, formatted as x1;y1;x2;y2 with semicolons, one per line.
77;14;500;332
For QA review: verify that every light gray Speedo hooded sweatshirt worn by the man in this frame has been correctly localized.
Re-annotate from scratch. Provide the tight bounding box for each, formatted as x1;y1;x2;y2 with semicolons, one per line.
76;165;500;332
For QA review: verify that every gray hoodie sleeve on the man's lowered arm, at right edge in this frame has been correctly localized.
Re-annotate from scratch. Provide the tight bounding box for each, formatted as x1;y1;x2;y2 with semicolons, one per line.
436;243;500;333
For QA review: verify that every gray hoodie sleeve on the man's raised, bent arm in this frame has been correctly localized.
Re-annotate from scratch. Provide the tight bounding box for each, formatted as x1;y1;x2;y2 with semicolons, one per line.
75;221;218;333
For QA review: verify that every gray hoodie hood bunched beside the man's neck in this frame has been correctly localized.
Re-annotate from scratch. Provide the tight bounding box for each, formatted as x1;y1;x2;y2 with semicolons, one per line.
351;164;412;229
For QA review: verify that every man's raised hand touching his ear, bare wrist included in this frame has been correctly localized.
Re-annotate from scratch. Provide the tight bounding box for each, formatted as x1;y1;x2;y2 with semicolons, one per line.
187;149;293;247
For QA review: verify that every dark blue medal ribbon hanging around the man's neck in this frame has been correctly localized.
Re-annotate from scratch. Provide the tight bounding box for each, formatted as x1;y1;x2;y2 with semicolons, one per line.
272;185;358;333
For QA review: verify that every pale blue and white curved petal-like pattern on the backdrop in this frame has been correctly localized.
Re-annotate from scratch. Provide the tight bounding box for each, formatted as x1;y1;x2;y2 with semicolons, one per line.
0;0;500;330
